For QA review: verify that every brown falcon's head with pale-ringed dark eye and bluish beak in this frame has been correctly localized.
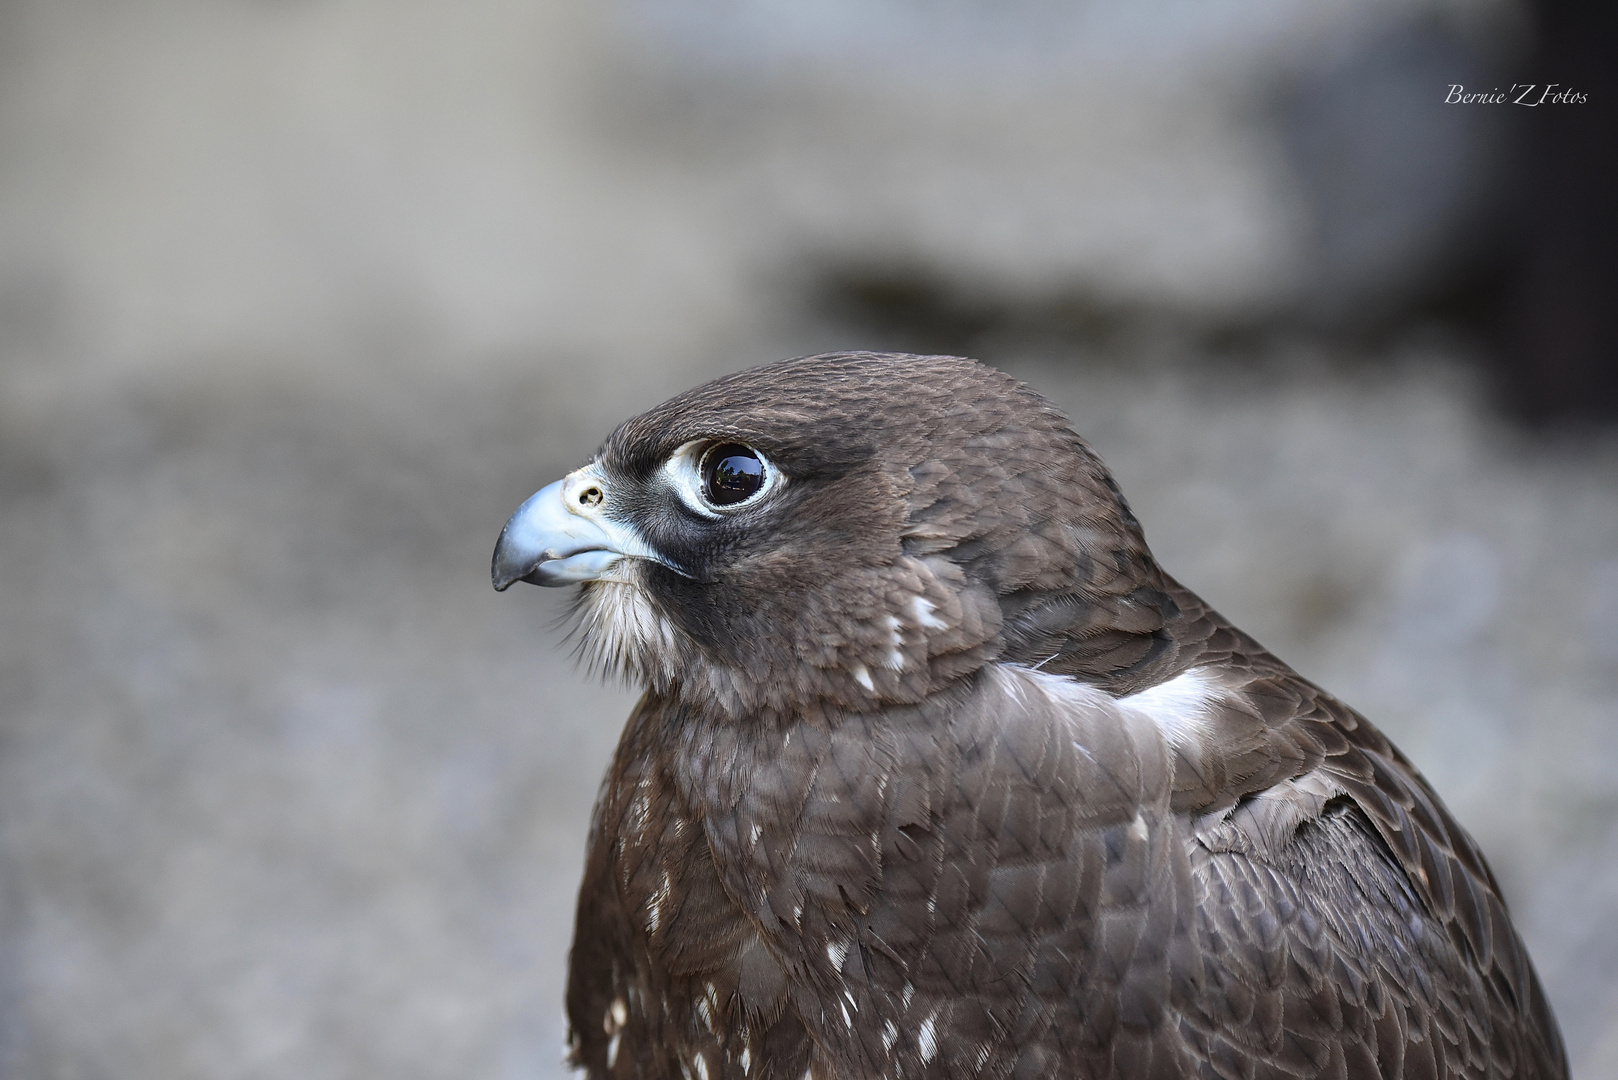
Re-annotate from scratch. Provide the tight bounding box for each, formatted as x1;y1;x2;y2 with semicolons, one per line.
492;353;1168;716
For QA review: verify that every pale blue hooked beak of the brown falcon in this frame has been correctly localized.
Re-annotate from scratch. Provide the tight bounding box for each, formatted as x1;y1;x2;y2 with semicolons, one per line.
490;465;646;593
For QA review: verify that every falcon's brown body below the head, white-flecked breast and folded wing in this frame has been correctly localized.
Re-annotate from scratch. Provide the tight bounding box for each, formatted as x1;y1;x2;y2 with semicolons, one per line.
570;591;1566;1080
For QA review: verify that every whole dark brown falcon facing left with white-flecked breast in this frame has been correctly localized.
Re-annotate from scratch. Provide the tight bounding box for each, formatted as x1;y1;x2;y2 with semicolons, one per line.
493;353;1568;1080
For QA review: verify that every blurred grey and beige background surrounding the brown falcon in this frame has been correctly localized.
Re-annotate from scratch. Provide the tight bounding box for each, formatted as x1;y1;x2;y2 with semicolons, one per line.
0;0;1618;1080
